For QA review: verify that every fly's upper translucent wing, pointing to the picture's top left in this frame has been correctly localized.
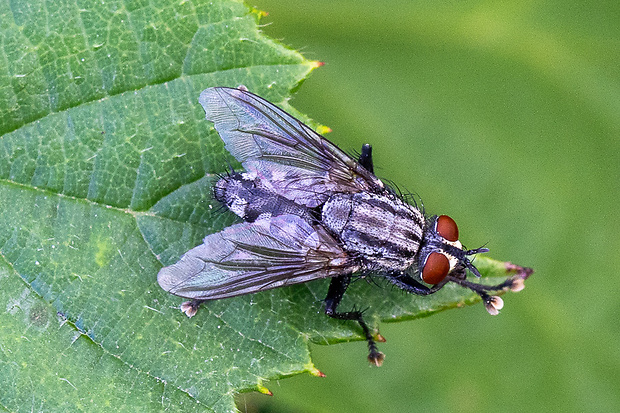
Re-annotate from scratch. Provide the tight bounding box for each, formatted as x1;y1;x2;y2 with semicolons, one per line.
199;87;384;208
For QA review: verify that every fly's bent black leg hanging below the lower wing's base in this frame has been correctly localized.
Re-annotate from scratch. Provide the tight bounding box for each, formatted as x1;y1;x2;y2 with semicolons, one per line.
325;275;385;367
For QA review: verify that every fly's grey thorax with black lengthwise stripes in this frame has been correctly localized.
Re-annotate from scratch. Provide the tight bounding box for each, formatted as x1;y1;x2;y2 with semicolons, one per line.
321;192;425;272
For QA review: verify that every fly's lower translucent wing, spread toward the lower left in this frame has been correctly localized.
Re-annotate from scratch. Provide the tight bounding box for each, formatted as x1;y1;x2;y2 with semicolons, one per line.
157;215;359;300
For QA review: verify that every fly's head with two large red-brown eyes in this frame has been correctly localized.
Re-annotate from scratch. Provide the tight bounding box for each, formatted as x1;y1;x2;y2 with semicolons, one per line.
418;215;489;285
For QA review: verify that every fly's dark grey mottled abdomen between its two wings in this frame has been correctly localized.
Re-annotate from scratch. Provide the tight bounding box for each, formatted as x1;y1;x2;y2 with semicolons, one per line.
213;173;312;222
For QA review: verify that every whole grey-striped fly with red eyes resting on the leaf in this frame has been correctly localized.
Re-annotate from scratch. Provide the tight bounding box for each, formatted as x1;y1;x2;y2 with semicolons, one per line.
157;87;529;366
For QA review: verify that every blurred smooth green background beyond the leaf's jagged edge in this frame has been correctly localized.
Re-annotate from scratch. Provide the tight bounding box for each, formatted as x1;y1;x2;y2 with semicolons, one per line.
238;0;620;412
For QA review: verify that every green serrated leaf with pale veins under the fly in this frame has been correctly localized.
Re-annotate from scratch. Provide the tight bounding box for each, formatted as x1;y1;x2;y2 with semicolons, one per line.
0;0;532;411
